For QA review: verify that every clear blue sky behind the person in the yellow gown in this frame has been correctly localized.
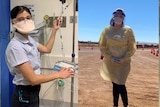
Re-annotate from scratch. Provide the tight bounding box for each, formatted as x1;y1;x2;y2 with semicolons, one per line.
78;0;159;43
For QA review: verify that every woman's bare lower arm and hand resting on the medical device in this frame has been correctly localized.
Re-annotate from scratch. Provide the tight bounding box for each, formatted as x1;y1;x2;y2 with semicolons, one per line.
16;62;75;86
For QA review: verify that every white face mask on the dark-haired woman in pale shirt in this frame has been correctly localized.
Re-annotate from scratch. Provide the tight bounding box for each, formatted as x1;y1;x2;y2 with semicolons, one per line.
13;20;35;34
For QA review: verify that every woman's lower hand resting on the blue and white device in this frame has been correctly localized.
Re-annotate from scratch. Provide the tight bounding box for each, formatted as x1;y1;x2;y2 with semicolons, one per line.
58;68;75;79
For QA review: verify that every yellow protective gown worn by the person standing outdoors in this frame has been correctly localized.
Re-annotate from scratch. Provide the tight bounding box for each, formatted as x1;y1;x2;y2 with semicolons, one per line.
99;26;136;85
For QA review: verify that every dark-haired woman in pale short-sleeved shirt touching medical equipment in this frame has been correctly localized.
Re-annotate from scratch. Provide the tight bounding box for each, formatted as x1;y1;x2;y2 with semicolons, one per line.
6;6;75;107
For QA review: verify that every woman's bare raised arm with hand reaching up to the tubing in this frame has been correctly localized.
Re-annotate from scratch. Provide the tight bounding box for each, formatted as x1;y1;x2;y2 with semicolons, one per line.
38;19;59;53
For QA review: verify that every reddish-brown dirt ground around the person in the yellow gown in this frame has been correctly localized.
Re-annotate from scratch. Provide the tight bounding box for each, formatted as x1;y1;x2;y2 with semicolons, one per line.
78;47;159;107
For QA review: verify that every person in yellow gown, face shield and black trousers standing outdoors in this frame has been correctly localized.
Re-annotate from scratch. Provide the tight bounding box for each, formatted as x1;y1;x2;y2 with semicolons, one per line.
99;8;136;107
